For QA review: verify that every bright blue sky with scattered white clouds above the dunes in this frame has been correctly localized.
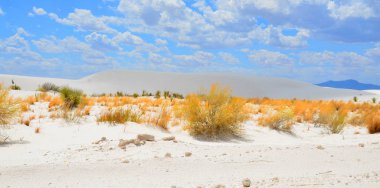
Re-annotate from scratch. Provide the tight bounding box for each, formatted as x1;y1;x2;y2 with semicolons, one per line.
0;0;380;84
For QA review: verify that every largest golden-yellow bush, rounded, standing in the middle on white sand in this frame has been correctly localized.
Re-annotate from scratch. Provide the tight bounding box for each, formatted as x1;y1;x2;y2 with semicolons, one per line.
182;84;248;138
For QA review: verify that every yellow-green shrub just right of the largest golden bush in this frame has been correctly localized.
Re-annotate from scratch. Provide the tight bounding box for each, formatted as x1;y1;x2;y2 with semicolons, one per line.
258;108;295;133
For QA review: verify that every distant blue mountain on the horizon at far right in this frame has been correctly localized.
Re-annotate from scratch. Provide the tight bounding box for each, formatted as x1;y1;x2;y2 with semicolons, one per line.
315;80;380;90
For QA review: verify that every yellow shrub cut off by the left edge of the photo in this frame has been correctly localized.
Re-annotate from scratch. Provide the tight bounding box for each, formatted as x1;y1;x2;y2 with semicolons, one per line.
0;85;20;126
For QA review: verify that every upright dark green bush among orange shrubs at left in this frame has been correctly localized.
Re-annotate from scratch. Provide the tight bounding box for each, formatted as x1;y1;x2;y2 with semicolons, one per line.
59;87;83;110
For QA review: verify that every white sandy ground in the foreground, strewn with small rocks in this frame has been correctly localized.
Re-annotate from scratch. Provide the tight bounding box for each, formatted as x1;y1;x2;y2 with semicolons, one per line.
0;84;380;187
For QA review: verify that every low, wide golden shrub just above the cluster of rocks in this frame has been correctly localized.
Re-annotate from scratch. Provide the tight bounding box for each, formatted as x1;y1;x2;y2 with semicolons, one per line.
97;107;142;125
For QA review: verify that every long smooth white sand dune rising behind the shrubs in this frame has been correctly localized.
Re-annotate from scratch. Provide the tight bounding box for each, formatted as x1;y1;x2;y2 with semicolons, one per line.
0;71;374;99
